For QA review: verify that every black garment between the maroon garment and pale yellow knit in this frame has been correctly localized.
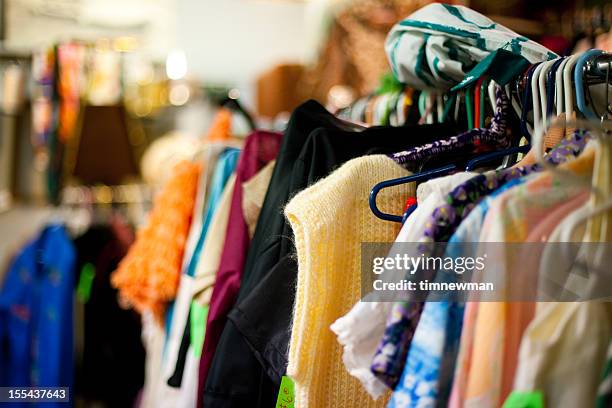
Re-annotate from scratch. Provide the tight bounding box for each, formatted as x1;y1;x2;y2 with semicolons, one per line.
204;101;457;408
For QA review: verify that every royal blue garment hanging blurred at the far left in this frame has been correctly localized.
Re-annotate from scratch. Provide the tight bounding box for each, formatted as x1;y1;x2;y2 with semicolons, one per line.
0;225;76;408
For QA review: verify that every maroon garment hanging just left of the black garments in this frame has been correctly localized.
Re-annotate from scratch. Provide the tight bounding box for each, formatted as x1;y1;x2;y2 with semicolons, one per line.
197;131;283;406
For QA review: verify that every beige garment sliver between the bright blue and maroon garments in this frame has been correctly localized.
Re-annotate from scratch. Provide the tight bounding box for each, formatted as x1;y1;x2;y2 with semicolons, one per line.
192;173;236;305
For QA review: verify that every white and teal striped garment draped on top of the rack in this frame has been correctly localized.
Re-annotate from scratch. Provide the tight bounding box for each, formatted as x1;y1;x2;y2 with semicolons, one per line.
385;3;557;90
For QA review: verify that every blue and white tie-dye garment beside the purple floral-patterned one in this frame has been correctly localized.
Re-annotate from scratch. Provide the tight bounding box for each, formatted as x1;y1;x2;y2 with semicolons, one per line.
387;178;525;408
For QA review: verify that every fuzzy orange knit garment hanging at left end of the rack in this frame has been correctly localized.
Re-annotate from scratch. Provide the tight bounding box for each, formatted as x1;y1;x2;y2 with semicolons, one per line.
111;161;201;322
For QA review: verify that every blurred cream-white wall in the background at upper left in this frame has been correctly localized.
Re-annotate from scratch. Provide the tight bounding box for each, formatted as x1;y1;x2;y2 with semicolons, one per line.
4;0;330;106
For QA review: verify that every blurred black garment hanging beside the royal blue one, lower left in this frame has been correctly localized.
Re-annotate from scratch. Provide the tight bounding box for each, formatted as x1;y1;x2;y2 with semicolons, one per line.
74;226;145;407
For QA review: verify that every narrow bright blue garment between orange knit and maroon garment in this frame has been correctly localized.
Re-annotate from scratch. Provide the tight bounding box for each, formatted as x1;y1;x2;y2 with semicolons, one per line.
187;147;240;276
